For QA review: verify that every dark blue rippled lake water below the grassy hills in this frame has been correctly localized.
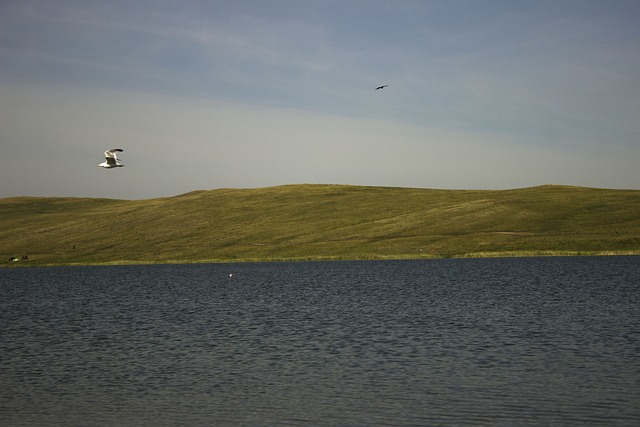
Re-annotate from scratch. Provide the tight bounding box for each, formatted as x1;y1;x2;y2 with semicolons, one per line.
0;257;640;426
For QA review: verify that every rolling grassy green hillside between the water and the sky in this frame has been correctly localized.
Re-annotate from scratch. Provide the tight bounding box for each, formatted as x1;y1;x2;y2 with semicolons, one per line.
0;185;640;267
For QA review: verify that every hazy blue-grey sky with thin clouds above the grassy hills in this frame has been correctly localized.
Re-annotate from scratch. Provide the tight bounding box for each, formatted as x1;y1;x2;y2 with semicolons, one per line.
0;0;640;199
